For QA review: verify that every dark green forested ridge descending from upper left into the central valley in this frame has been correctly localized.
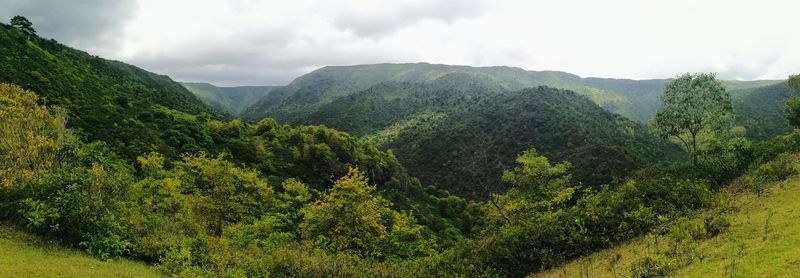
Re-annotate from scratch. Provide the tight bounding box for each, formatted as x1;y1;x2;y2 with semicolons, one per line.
0;20;464;238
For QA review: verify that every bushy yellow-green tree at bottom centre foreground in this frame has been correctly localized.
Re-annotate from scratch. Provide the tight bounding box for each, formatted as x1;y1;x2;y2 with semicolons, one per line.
300;168;426;258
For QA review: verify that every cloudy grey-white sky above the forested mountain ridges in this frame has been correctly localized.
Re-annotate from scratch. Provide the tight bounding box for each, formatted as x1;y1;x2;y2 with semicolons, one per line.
0;0;800;86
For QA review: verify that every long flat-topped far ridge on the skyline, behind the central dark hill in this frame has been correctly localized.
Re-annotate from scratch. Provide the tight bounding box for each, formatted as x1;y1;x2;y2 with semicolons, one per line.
242;63;656;121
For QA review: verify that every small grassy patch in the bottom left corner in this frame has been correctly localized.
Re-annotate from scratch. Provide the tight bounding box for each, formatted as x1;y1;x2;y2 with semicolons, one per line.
0;223;163;277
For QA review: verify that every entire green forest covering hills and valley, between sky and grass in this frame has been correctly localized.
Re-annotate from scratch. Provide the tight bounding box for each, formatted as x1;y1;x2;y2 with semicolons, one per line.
0;17;800;277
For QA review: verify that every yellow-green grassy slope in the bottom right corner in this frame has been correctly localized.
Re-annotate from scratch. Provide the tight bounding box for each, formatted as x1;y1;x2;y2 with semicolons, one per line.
530;154;800;277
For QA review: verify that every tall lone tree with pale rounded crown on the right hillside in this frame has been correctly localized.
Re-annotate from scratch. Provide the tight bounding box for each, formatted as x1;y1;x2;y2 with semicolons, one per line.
652;73;733;165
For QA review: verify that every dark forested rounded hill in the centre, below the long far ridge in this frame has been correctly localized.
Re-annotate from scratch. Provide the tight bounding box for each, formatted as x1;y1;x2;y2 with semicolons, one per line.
290;73;676;196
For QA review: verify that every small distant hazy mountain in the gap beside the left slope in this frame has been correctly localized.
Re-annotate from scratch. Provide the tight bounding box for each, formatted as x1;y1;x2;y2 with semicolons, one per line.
181;82;281;116
